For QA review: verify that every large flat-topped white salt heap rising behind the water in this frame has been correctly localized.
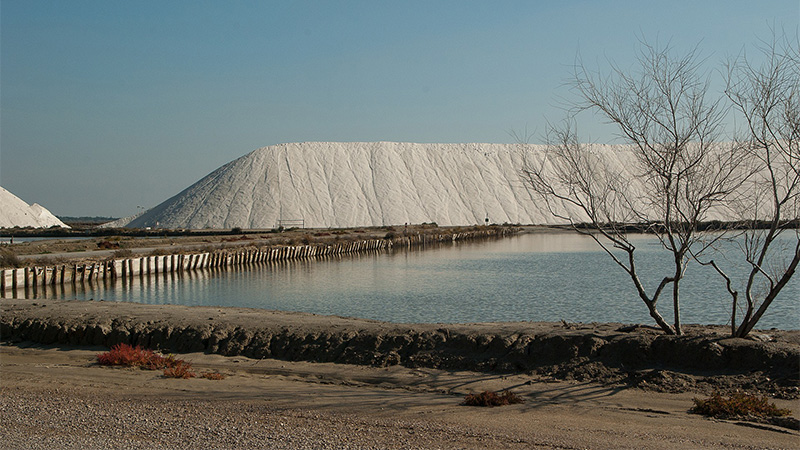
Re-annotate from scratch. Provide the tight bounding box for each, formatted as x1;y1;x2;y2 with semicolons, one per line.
126;142;629;229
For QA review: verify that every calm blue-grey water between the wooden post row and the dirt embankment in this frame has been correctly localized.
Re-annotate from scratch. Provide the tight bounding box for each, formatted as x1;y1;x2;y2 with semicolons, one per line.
5;234;800;329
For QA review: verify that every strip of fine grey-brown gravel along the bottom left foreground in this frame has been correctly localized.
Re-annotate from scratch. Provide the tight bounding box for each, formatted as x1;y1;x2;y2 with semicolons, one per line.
0;389;540;450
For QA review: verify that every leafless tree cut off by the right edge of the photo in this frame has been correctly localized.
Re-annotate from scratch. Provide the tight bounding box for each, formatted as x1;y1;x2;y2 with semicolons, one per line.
708;34;800;337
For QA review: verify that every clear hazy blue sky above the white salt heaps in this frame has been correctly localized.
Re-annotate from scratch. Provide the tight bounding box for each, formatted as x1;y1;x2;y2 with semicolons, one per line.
0;0;800;216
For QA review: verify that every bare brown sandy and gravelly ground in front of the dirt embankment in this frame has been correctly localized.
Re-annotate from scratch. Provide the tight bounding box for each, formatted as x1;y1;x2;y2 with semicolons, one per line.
0;343;800;449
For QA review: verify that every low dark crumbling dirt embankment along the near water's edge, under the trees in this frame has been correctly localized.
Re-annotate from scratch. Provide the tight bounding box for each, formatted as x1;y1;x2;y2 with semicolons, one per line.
0;299;800;398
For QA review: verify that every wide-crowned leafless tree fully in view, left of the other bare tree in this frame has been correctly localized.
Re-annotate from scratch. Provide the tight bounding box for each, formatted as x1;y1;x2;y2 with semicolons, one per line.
523;43;747;334
